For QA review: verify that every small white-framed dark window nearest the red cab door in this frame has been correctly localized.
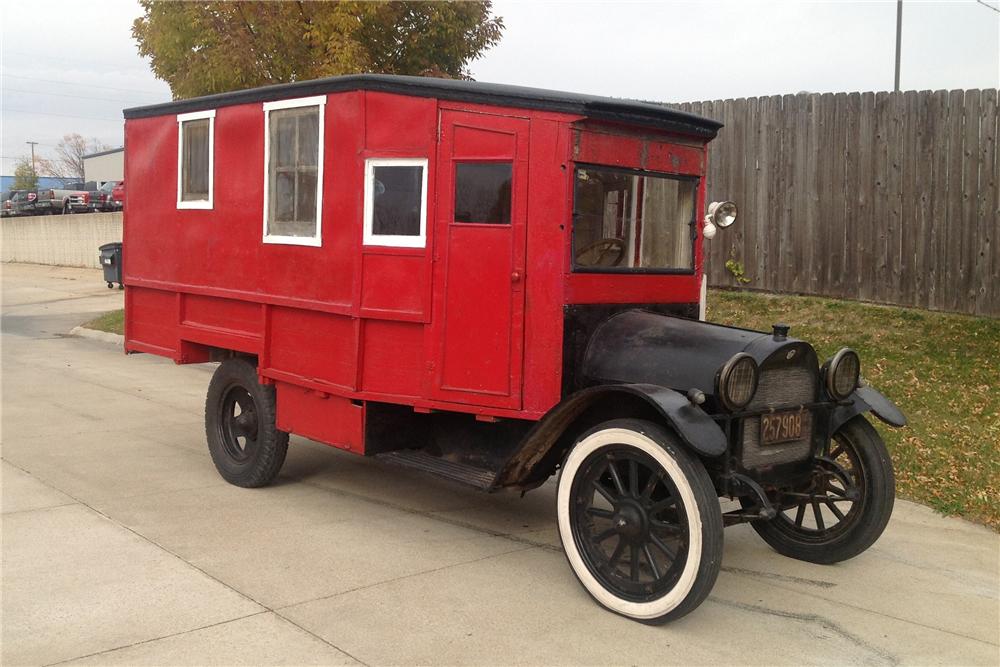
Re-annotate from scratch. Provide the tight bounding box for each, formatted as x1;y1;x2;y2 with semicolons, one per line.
364;158;427;248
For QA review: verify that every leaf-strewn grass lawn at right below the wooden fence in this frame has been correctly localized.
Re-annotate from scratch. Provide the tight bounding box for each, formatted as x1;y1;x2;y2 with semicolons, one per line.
708;290;1000;529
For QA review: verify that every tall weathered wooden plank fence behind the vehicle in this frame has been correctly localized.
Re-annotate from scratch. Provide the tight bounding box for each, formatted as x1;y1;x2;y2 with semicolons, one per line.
670;89;1000;317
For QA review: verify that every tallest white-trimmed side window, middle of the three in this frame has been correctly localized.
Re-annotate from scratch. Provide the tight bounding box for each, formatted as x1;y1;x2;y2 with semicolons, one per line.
264;97;326;246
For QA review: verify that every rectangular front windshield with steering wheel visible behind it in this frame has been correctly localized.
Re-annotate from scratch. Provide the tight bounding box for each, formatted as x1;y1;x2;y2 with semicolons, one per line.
573;166;698;273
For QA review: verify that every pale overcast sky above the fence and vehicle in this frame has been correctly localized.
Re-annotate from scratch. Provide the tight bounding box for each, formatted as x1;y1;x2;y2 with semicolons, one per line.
0;0;1000;175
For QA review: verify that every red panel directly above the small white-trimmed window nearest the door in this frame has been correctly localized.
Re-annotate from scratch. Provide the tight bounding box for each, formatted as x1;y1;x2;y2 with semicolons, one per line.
364;91;437;151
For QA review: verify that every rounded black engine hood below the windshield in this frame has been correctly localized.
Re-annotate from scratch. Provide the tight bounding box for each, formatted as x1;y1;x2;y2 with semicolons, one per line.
583;310;817;396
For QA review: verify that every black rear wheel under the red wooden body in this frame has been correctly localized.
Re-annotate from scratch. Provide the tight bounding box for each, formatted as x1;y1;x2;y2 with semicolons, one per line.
205;359;288;487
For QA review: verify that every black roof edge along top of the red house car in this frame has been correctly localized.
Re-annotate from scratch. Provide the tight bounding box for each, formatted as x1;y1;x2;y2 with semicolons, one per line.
125;74;722;139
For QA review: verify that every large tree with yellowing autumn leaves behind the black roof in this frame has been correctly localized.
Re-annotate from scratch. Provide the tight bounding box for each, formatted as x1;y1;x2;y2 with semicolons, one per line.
132;0;503;99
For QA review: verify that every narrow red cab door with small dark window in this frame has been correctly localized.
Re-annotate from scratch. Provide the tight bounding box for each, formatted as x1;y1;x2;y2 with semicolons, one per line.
429;111;528;409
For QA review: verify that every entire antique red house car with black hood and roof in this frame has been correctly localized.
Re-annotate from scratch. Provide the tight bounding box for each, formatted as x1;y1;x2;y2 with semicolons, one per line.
124;75;905;622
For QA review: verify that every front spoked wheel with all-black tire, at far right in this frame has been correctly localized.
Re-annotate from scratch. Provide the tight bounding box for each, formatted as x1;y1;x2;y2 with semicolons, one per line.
744;415;895;563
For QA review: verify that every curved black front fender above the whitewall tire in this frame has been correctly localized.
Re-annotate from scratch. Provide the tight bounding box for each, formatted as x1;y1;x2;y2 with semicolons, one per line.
496;384;728;488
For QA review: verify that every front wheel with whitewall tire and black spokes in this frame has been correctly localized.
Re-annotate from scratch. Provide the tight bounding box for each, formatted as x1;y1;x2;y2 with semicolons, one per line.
557;419;722;623
